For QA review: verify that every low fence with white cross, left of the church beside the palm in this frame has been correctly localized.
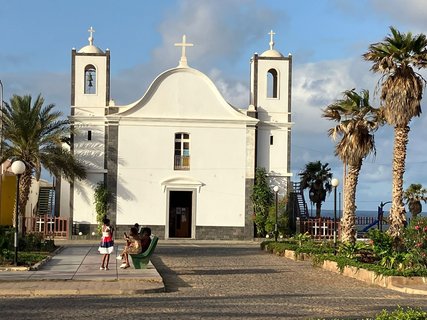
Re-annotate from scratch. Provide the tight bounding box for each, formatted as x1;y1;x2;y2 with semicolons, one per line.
25;214;68;239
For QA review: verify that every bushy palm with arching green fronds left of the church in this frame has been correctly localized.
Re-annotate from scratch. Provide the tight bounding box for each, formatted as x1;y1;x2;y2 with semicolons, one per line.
1;95;86;232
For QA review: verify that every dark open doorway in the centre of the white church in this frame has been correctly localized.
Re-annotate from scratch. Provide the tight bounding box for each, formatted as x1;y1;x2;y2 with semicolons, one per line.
169;191;193;238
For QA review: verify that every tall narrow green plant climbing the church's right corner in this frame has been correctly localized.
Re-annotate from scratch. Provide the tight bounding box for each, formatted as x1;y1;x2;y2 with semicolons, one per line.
251;168;273;237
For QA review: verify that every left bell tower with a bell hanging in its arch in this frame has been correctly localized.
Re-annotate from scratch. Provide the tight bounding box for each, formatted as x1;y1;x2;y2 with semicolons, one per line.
64;27;116;233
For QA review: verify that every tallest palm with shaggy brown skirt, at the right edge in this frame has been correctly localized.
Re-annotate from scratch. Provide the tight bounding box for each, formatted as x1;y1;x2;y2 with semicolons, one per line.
363;27;427;238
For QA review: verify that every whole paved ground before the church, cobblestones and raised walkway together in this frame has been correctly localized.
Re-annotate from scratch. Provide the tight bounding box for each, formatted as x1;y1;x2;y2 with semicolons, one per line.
0;241;427;319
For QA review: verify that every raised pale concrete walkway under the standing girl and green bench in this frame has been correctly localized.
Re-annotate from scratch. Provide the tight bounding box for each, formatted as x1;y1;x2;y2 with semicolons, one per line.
0;242;165;296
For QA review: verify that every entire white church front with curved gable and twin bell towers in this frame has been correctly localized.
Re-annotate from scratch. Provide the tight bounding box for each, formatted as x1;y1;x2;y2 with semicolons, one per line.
59;28;292;239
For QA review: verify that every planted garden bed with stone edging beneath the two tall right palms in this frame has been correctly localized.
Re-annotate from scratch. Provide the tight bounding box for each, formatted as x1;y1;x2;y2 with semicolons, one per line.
261;217;427;277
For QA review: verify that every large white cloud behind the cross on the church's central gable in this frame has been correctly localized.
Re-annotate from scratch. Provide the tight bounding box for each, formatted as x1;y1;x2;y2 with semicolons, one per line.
154;0;283;69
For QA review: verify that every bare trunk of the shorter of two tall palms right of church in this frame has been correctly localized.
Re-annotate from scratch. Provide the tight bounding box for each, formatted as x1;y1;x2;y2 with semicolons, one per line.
341;161;362;244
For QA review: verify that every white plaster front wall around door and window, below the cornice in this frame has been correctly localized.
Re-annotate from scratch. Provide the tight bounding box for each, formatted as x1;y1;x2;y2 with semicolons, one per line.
117;123;246;227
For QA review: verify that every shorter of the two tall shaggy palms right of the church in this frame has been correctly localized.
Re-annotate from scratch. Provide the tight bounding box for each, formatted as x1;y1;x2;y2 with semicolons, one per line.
322;89;382;244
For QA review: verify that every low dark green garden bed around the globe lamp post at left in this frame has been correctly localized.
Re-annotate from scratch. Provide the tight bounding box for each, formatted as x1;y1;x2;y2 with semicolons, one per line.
0;227;57;268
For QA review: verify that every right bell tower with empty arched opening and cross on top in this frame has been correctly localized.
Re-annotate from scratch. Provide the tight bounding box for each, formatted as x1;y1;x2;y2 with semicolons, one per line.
250;31;292;188
